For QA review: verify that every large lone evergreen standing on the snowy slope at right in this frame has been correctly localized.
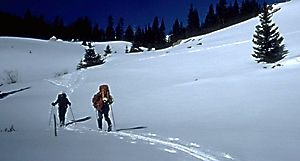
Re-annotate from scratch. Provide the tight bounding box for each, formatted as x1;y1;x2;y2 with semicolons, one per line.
252;3;288;63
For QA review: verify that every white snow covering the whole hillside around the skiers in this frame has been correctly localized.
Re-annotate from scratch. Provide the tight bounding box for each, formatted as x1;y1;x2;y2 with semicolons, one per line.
0;1;300;161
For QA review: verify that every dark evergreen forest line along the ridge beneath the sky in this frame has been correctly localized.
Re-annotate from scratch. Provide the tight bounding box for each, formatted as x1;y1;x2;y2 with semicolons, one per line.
0;0;261;49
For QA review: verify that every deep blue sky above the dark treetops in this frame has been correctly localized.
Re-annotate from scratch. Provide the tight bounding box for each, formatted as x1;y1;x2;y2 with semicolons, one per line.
0;0;276;30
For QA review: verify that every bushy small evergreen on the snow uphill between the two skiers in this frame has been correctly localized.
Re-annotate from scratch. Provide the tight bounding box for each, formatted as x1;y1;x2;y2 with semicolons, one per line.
77;43;105;70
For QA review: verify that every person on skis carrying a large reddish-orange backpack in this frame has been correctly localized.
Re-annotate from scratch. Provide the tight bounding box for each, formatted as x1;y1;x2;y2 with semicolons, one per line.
92;85;114;132
